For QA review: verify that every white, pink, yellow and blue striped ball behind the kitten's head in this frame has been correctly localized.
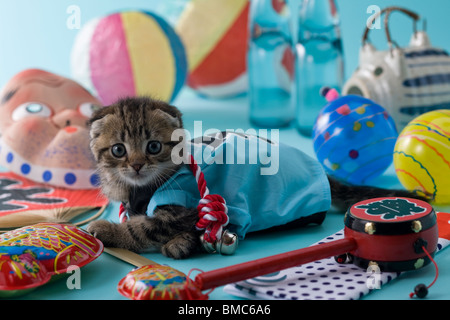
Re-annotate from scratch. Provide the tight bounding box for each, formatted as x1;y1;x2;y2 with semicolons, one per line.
71;11;187;105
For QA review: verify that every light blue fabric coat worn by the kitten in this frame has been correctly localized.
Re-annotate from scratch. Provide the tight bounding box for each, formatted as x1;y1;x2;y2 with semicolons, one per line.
147;132;331;239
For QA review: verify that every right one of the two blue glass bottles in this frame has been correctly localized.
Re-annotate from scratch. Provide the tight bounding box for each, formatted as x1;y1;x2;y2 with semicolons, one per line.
295;0;344;136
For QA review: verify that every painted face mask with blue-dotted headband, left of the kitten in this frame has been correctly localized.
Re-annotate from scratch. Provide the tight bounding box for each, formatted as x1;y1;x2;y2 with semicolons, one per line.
0;69;101;189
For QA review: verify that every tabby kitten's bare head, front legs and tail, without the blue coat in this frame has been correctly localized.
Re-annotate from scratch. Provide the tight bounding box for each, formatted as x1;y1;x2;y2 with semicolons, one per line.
88;97;428;259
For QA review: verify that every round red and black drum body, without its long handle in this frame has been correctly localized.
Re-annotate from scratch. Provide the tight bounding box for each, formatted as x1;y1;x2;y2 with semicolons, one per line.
344;198;438;272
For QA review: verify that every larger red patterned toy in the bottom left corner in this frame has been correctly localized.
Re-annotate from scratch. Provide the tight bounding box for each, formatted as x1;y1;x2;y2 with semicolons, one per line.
0;223;103;297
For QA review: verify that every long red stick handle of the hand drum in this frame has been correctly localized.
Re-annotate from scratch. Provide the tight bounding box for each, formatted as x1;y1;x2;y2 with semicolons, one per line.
195;238;357;290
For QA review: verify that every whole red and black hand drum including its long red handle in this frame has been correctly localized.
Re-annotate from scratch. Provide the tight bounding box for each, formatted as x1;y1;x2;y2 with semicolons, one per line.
195;198;438;289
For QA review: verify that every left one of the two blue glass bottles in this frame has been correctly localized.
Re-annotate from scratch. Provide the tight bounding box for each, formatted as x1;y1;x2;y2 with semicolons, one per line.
247;0;297;128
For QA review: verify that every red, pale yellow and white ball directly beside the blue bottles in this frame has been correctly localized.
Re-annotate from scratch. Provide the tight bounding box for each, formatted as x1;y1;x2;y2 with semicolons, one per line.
176;0;249;98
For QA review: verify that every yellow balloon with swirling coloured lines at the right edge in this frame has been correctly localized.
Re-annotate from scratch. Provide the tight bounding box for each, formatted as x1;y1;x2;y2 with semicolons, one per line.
394;110;450;204
